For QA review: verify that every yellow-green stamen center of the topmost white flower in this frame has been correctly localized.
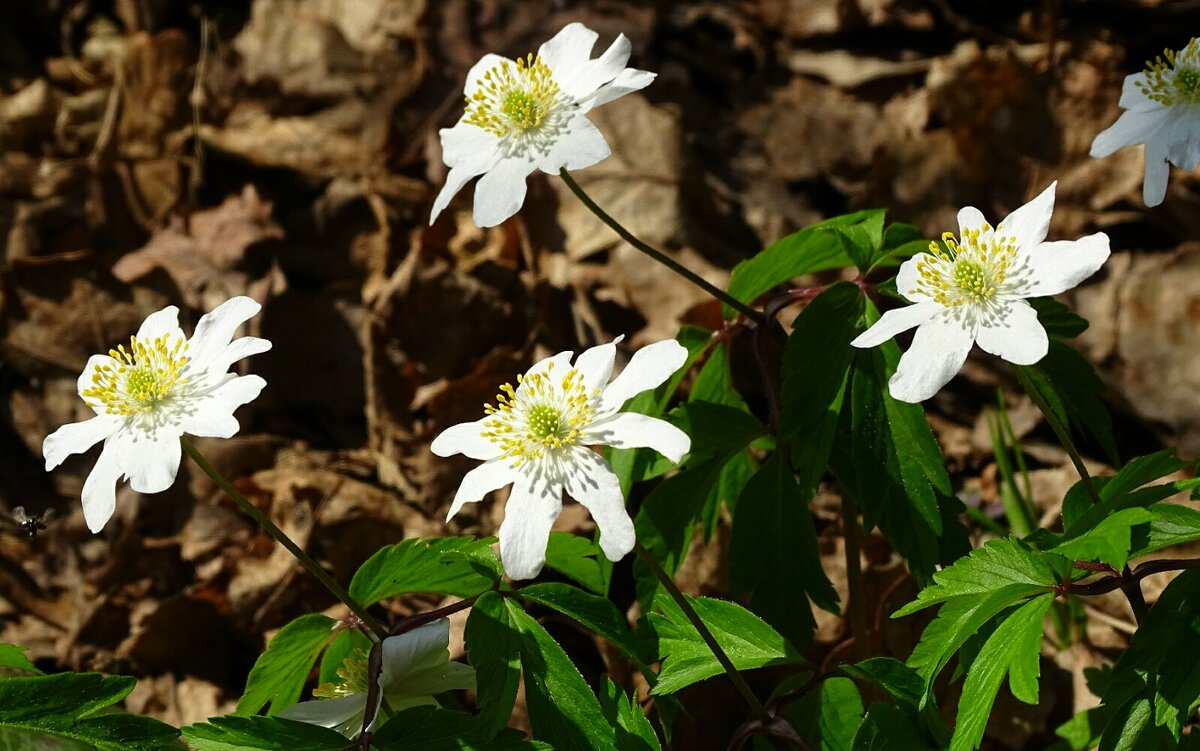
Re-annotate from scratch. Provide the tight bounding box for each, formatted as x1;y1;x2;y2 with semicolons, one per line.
467;54;558;138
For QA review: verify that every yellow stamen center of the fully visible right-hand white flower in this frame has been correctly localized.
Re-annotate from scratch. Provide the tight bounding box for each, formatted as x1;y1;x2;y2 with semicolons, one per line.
917;224;1016;307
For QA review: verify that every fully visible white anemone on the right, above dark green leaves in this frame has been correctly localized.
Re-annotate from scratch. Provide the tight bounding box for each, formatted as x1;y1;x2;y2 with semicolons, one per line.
851;184;1109;402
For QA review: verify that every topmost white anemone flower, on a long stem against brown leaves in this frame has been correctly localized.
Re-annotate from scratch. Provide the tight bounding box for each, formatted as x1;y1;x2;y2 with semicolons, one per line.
430;23;654;227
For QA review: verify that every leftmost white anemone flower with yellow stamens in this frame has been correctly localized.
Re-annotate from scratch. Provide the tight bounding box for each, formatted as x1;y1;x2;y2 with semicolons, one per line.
42;298;271;533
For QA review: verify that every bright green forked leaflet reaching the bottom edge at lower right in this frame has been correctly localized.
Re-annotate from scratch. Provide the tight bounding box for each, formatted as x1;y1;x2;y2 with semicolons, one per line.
950;593;1055;751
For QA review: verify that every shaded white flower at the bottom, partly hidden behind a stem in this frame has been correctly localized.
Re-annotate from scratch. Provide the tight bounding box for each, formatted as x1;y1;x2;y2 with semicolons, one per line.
277;618;475;738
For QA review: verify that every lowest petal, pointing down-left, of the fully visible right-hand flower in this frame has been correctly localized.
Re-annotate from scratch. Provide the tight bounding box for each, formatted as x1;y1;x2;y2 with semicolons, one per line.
888;310;974;402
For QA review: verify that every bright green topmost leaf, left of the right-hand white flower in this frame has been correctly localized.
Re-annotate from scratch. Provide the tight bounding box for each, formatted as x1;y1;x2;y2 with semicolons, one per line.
725;209;882;318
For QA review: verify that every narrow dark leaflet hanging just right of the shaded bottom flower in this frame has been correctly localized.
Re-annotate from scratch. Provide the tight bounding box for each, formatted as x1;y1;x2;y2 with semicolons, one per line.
464;591;521;738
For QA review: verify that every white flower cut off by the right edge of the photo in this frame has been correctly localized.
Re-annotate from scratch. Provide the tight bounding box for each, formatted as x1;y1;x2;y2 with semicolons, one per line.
1091;38;1200;206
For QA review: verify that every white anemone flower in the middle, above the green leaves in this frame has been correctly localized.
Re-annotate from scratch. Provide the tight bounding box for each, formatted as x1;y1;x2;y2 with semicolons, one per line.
431;337;691;579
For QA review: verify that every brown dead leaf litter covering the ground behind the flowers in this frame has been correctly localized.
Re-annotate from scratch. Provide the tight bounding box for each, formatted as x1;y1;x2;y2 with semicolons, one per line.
0;0;1200;749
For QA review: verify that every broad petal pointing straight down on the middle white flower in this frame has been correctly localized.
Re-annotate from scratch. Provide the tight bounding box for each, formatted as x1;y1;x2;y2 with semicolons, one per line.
500;476;563;579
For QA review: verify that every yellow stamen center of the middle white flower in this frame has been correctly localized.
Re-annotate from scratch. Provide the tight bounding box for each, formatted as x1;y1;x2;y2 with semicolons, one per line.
481;362;600;467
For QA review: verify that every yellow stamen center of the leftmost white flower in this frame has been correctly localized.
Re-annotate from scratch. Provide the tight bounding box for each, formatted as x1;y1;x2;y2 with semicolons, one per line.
82;334;188;415
